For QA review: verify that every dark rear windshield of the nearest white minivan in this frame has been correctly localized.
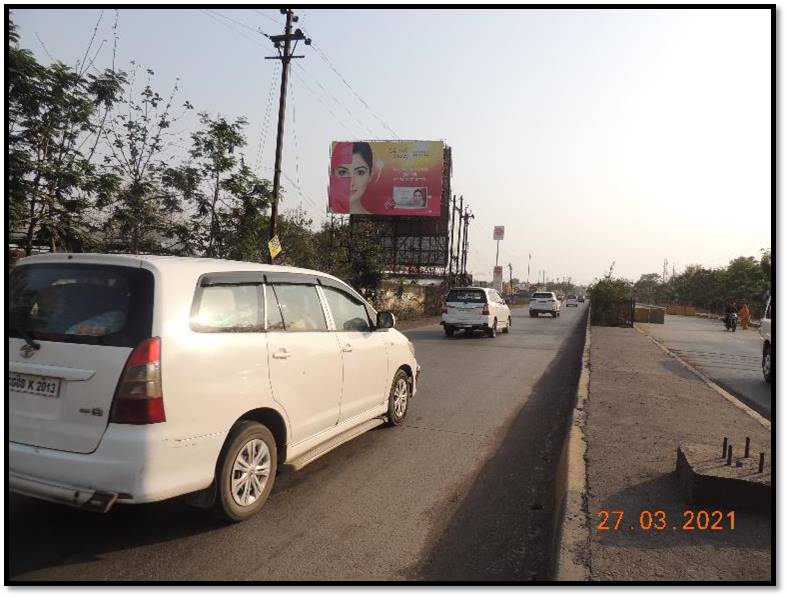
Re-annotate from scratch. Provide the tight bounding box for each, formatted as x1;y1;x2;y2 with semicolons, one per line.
9;263;153;347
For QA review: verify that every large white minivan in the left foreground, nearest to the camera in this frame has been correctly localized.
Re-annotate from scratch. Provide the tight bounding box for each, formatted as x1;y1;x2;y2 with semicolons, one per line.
8;254;419;521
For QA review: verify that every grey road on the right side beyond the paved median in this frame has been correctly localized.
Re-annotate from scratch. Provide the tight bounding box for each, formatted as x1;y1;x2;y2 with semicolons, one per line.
637;315;771;419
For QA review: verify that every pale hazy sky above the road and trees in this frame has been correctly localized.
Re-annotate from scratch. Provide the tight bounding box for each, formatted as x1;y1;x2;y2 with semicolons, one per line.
14;9;771;283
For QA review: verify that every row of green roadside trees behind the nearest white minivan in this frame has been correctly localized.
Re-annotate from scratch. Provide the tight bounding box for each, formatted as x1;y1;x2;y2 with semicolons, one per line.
6;18;382;298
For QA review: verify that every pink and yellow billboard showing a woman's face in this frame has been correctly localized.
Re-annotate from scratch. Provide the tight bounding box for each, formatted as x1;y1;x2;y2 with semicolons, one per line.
328;141;444;217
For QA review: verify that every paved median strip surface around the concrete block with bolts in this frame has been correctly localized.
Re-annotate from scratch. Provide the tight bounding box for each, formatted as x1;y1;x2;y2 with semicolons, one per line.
584;327;772;581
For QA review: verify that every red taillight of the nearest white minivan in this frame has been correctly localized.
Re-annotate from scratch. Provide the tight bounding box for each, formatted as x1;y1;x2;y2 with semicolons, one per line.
109;338;167;425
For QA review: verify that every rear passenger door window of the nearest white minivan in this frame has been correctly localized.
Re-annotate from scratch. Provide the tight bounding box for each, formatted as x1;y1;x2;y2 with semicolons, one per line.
267;284;328;332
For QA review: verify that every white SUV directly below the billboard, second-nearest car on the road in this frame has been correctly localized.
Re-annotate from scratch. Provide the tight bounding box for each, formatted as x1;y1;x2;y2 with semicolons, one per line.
440;286;511;338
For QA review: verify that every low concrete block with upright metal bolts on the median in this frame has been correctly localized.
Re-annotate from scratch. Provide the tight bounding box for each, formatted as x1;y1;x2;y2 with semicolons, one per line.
676;442;771;513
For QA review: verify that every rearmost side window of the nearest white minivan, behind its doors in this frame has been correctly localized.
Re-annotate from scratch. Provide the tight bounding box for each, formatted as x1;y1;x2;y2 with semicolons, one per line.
191;284;263;332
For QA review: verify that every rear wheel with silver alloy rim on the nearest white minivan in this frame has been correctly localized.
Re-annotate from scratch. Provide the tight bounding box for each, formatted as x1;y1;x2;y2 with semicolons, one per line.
213;421;278;522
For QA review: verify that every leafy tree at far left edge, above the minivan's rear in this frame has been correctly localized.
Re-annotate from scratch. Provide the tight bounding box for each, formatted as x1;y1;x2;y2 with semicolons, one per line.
8;15;125;255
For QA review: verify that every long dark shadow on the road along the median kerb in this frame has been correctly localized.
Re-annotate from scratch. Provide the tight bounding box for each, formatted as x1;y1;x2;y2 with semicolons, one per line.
416;312;587;582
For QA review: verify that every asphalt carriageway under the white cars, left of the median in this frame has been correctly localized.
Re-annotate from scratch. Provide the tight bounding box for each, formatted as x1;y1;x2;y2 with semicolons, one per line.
6;306;586;582
